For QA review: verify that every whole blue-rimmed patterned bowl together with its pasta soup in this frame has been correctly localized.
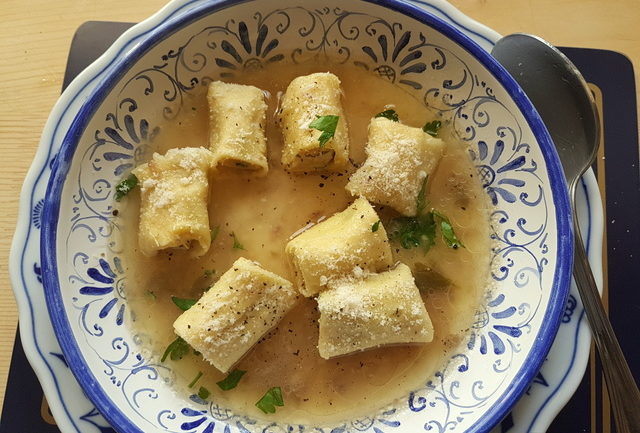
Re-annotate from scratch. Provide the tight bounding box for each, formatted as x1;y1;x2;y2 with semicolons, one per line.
42;0;571;433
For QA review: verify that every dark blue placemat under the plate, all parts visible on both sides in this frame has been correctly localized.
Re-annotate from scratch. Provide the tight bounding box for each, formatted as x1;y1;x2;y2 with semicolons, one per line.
0;21;640;433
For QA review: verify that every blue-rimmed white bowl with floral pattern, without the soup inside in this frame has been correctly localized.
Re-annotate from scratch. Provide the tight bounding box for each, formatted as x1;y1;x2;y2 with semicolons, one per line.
35;0;572;433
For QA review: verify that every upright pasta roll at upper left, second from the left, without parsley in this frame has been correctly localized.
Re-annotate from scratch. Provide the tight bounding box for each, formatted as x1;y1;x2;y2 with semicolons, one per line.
207;81;269;175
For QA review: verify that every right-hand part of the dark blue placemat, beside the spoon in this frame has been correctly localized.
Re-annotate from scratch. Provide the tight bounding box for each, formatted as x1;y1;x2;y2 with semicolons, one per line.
548;48;640;433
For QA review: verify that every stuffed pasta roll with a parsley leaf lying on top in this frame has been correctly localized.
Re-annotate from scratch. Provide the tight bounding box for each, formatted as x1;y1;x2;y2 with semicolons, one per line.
280;72;349;172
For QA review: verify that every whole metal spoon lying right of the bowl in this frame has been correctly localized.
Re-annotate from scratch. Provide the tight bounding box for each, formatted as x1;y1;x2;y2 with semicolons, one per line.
491;34;640;433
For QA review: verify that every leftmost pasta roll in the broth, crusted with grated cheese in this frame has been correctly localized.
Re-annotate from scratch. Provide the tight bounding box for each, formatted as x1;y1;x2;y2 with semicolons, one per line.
133;147;213;256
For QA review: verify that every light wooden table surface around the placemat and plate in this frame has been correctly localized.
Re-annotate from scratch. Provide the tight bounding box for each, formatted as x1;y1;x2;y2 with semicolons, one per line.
0;0;640;412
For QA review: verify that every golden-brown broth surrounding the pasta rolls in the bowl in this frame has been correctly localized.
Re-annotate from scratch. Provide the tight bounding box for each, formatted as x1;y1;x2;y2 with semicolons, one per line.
120;65;490;424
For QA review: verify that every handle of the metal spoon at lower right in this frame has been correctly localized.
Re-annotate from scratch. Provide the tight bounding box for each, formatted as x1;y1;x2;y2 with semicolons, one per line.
573;212;640;433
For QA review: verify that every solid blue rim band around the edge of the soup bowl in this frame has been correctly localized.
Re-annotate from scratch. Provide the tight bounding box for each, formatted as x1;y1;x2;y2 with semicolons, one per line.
40;0;573;433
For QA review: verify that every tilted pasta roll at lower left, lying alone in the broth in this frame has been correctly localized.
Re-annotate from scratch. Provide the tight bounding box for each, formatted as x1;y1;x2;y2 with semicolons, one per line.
173;257;299;373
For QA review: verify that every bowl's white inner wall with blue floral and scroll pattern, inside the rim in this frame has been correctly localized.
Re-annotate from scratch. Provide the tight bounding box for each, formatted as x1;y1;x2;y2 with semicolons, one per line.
47;1;555;433
